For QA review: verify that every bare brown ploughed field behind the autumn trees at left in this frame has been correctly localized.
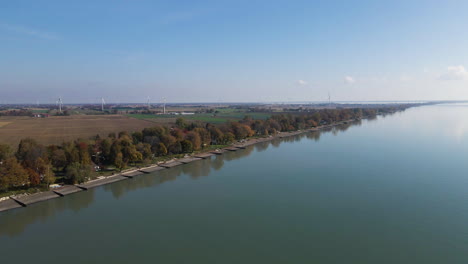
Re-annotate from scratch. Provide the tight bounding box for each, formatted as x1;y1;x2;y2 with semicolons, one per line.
0;115;154;148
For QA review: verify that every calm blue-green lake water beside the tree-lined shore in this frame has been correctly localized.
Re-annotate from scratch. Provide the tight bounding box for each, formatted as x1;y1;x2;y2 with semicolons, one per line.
0;105;468;264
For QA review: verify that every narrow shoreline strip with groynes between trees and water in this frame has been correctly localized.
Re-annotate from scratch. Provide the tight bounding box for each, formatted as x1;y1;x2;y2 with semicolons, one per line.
0;120;357;213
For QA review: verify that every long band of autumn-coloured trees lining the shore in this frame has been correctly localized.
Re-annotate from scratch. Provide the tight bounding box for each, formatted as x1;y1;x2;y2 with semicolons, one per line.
0;106;405;192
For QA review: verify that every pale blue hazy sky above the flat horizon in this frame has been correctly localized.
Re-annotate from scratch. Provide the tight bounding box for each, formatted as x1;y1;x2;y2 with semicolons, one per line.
0;0;468;103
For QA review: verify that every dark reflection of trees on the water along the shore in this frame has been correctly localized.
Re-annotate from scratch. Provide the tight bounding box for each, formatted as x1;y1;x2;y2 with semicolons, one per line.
0;122;360;237
